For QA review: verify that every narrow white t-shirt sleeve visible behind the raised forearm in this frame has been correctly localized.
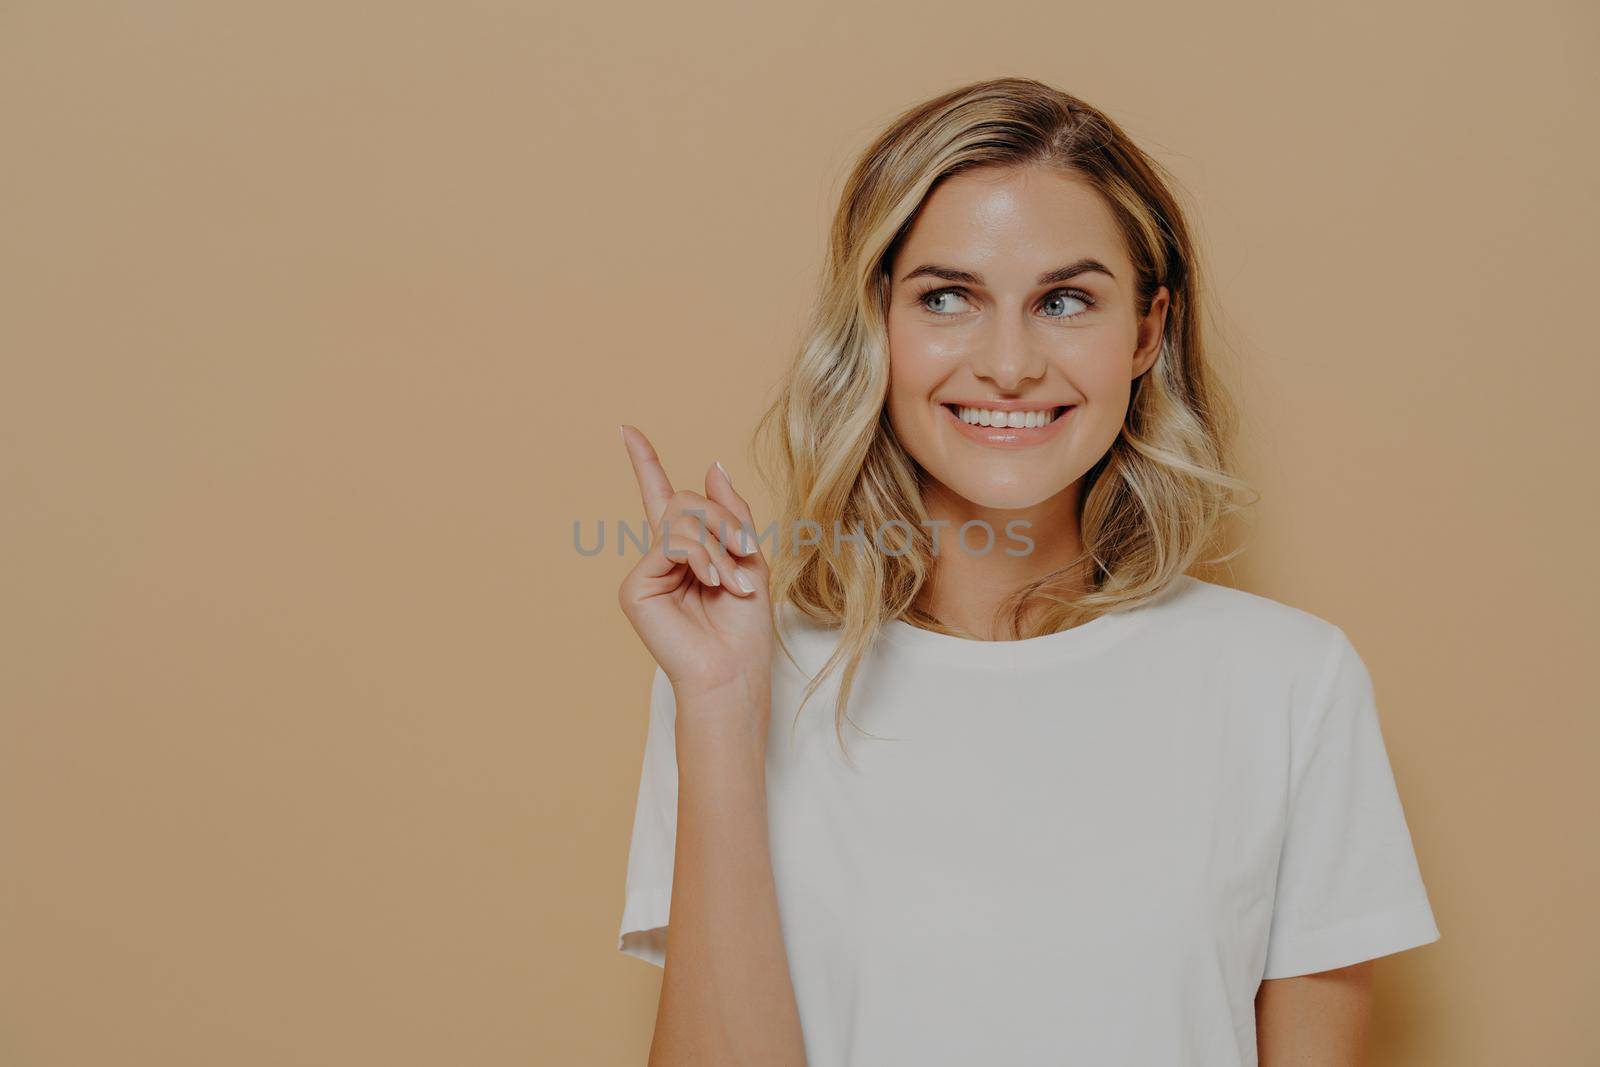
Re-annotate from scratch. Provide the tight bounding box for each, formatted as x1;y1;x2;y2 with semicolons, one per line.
616;667;678;966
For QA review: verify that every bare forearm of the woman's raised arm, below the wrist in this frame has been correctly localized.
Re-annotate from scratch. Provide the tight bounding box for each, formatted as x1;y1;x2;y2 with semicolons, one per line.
650;685;805;1067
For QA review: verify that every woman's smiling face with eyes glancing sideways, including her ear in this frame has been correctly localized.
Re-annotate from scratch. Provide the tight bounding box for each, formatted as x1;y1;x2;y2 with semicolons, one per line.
888;166;1168;509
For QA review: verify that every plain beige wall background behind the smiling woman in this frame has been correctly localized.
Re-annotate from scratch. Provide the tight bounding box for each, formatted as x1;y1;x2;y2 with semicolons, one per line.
0;0;1600;1067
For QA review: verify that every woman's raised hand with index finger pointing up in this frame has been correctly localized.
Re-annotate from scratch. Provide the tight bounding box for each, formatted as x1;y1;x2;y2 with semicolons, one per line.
618;426;774;697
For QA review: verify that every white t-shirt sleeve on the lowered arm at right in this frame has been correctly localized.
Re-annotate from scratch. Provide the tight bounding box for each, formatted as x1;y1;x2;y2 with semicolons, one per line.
1262;627;1438;979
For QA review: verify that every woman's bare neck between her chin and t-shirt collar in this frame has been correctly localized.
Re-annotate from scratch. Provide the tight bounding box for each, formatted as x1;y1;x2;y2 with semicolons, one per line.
917;480;1090;641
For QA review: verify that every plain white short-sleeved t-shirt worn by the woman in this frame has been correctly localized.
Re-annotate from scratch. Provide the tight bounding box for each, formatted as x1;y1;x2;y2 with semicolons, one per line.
618;576;1438;1067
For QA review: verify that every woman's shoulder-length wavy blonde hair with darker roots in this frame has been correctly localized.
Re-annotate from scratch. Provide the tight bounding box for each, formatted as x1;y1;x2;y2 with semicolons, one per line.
757;78;1258;758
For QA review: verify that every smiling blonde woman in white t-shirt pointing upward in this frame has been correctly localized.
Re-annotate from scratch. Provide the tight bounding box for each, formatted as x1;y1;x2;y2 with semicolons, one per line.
619;78;1438;1067
